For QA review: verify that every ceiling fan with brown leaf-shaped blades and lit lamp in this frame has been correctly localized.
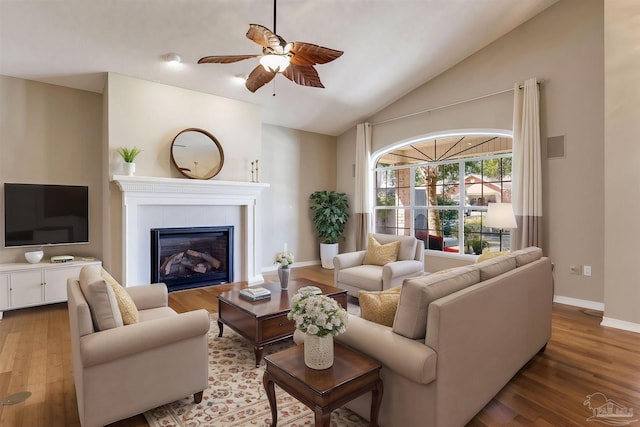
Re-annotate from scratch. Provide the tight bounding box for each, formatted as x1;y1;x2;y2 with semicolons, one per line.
198;0;343;92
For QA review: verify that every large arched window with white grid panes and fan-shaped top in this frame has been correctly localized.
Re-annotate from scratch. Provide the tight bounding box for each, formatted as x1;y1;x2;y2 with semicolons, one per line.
374;132;511;254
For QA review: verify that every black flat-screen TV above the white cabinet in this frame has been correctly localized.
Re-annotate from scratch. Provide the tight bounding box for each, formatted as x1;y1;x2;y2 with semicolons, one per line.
4;183;89;248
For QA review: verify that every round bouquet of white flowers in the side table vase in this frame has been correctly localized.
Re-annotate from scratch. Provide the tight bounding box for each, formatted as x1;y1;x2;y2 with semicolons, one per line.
287;286;349;337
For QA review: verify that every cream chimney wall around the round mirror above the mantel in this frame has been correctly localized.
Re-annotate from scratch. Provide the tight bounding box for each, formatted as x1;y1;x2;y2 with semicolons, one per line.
103;73;262;280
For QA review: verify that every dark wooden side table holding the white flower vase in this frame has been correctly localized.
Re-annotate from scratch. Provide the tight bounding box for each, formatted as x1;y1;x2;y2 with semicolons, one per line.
262;343;382;427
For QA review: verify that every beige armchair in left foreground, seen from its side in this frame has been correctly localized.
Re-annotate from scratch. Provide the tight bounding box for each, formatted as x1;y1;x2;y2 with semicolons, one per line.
67;267;209;427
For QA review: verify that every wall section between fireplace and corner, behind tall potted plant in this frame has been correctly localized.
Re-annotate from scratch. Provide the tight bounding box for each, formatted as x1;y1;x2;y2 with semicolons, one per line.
260;125;337;267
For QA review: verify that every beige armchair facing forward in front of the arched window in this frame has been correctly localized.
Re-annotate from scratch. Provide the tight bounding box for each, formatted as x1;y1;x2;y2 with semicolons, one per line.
333;234;424;298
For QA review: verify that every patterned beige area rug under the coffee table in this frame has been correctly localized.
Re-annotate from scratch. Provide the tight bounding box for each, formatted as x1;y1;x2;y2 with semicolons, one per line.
144;313;369;427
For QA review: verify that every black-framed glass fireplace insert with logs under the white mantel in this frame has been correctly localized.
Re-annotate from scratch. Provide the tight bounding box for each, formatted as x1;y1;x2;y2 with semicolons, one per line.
151;226;233;291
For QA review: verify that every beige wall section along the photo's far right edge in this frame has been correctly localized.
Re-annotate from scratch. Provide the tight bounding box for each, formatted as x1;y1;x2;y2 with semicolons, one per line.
604;0;640;332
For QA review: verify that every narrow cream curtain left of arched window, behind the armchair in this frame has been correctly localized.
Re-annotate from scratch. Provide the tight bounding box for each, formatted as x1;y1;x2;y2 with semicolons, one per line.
354;123;371;251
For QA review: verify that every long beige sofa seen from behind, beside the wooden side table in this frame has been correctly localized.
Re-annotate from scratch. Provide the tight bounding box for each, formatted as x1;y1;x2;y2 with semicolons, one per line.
336;248;553;427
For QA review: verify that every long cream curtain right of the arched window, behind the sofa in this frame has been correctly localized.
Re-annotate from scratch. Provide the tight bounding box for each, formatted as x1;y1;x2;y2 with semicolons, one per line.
511;78;542;251
